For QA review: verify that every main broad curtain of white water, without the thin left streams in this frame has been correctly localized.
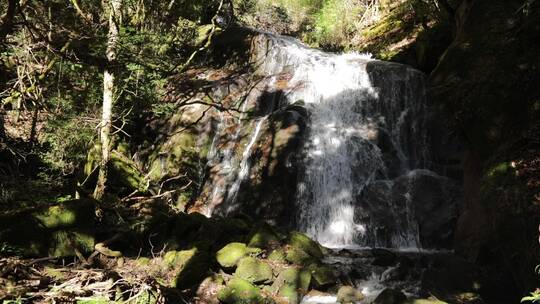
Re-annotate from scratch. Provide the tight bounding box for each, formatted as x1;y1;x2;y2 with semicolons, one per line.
252;35;424;247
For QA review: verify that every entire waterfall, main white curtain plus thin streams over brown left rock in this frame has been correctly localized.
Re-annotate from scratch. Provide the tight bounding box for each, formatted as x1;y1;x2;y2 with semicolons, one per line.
201;30;442;248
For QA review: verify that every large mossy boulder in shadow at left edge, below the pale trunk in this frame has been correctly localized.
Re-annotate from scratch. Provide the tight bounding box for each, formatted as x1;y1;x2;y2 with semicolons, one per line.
0;199;95;257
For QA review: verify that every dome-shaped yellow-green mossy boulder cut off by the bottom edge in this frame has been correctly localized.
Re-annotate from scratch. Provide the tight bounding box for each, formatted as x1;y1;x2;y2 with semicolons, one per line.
217;278;264;304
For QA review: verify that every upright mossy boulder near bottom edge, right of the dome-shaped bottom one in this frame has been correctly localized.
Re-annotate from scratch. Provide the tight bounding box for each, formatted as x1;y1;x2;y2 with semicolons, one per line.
270;267;311;303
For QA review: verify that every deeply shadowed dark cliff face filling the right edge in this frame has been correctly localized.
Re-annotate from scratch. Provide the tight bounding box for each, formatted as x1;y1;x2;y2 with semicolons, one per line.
430;0;540;291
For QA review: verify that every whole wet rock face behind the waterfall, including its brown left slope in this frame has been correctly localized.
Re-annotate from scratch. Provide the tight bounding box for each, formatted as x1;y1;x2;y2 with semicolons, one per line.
160;30;457;248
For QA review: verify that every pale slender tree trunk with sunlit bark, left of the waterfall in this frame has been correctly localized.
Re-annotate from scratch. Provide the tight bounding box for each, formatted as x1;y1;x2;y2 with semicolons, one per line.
94;0;122;200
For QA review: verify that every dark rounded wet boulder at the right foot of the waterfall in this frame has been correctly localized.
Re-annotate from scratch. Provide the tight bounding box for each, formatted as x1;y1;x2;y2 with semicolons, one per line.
356;170;461;248
